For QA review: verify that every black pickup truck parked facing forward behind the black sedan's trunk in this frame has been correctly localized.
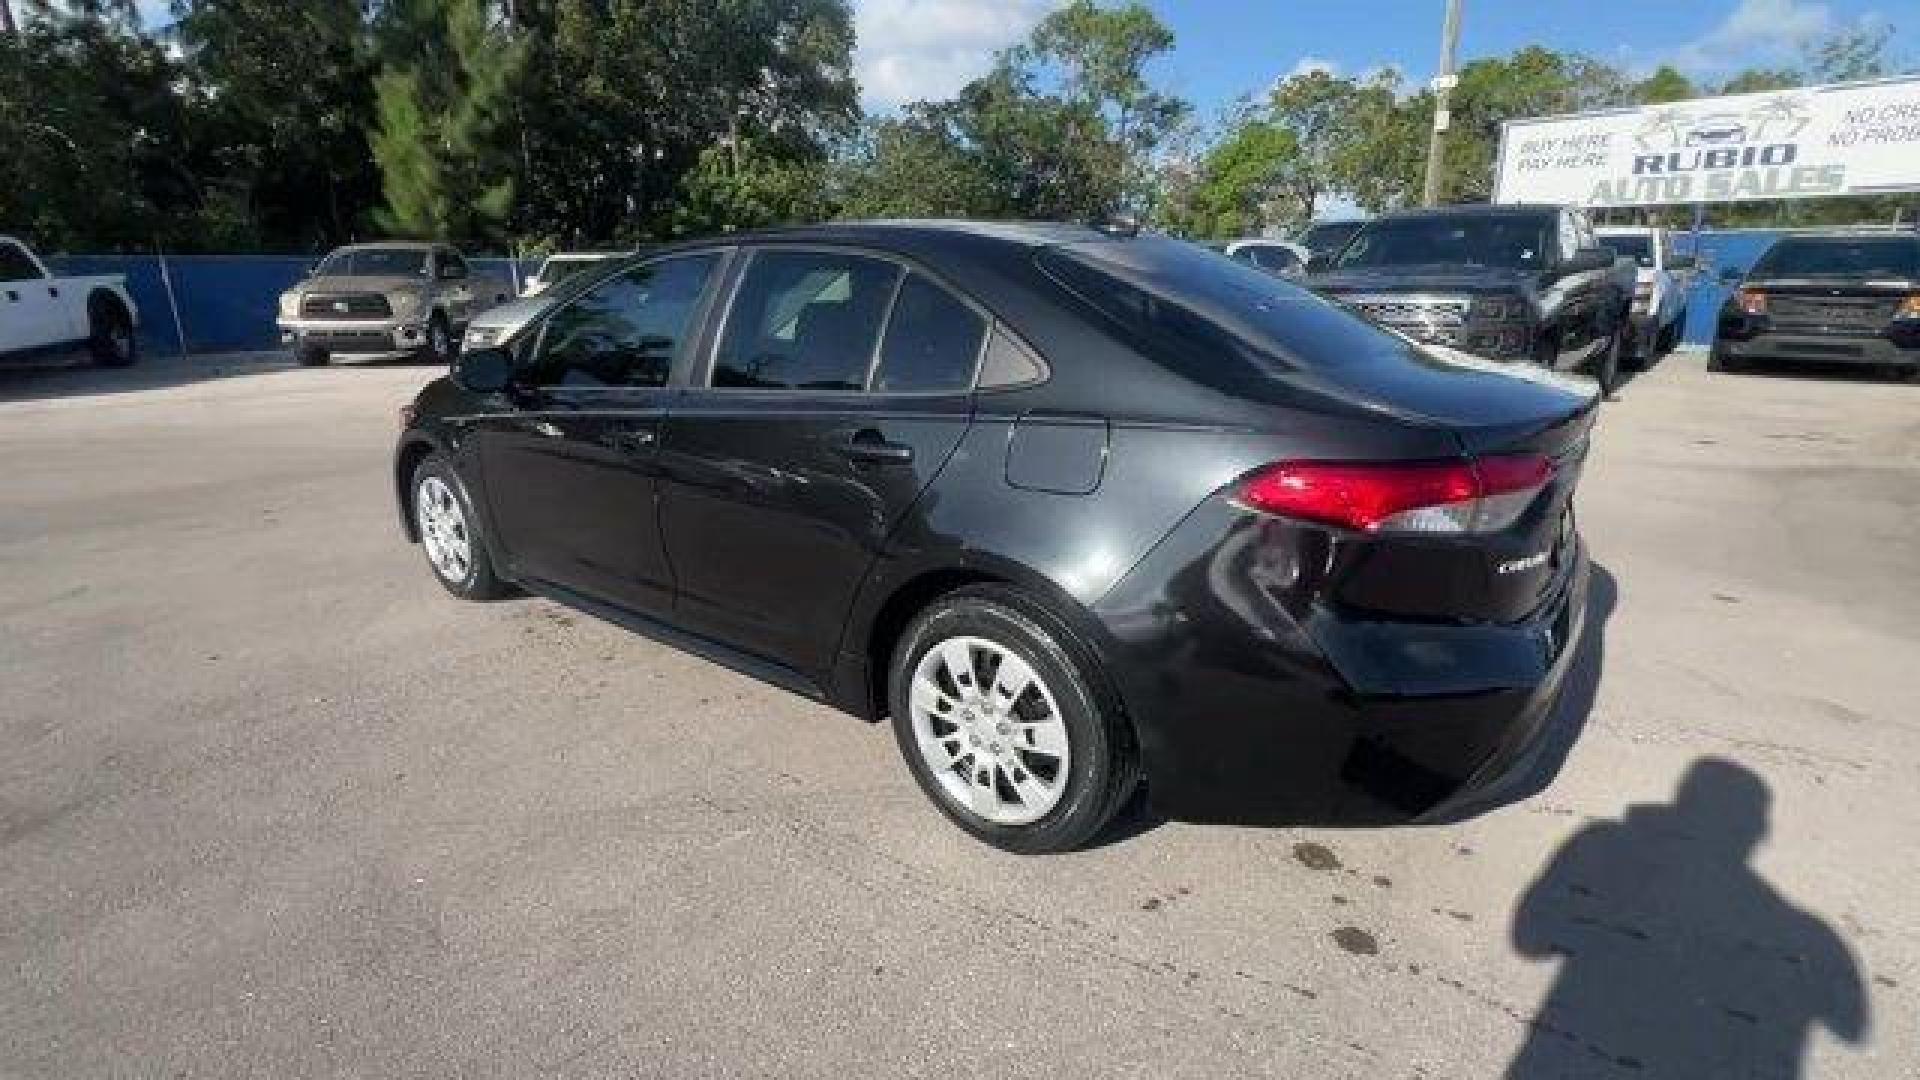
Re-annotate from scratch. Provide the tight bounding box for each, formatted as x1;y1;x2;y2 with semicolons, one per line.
1308;206;1634;390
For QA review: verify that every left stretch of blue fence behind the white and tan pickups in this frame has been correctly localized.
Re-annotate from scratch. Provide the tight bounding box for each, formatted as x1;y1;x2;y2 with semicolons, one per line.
48;256;522;354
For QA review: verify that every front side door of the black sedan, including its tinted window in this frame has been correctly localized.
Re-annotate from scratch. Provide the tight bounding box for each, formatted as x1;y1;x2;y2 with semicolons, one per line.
472;250;726;615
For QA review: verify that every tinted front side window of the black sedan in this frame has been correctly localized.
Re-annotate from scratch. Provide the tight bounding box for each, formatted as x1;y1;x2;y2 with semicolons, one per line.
528;254;720;386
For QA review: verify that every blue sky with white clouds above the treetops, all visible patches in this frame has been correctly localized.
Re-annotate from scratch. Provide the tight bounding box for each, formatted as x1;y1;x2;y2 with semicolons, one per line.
854;0;1920;119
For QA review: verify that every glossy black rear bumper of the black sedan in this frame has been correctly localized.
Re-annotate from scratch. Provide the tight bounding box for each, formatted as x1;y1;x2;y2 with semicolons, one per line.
1096;499;1590;826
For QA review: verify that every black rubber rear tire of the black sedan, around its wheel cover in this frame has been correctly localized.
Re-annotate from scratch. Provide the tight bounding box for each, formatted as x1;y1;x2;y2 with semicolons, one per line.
887;586;1139;855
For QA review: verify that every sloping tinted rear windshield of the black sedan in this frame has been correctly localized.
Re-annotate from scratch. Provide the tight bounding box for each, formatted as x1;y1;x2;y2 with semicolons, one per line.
1039;236;1409;394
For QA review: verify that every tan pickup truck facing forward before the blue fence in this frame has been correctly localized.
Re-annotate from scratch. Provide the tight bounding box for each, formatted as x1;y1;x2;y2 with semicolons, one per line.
276;242;513;367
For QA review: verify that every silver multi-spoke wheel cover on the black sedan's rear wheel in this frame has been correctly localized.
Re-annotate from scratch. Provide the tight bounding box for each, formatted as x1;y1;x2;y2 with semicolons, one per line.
908;636;1071;824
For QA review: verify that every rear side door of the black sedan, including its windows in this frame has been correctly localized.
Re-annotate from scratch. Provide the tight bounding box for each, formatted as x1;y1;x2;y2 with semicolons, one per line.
660;246;989;675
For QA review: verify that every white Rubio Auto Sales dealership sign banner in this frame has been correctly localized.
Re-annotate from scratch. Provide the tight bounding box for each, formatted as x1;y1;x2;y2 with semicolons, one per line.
1494;77;1920;206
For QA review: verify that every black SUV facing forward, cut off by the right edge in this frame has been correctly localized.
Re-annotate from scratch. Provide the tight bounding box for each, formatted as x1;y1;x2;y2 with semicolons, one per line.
1709;234;1920;379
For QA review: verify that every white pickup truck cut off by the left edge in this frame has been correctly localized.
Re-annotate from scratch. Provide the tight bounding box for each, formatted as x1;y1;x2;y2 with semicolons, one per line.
0;236;140;367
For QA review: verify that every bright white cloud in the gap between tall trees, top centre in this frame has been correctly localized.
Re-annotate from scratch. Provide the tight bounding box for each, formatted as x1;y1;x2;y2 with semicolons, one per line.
852;0;1056;108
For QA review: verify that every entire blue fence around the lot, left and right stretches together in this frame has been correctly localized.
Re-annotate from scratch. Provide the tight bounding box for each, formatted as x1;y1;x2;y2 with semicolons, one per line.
37;229;1843;352
